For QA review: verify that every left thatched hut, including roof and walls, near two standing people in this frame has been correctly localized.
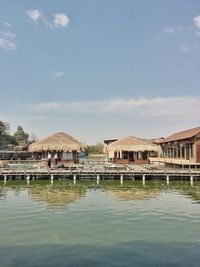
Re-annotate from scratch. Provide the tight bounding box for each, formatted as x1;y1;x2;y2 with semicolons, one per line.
29;132;87;163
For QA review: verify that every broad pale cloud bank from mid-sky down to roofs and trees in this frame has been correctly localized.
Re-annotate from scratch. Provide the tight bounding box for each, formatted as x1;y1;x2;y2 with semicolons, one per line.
0;96;200;144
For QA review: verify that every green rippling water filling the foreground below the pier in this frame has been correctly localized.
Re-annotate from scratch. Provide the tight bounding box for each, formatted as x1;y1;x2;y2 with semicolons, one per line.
0;181;200;267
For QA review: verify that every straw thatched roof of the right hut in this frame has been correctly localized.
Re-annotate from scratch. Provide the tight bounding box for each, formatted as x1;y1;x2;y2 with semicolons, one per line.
107;136;159;152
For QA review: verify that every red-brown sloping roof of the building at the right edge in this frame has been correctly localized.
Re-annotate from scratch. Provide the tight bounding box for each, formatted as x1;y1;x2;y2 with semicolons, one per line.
160;127;200;143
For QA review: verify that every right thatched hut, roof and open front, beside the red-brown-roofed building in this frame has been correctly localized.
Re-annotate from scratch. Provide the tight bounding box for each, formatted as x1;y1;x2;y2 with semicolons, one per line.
106;136;159;164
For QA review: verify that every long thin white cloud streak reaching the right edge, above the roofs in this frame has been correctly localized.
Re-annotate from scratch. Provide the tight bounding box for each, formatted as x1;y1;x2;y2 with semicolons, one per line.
34;96;200;118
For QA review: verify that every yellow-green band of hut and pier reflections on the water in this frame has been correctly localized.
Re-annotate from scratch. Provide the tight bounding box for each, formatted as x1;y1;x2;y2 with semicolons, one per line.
0;180;200;206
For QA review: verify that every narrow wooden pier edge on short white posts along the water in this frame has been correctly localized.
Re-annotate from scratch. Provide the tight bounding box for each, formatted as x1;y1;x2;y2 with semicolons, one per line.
0;169;200;181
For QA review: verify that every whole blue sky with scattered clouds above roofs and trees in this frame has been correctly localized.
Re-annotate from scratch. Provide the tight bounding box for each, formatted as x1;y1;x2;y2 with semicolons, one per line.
0;0;200;147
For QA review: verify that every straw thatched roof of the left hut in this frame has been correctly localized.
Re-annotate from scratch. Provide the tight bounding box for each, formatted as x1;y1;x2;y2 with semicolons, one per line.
29;132;86;152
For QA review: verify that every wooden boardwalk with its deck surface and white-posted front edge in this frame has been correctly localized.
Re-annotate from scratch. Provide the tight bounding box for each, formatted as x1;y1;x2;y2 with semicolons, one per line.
0;165;200;180
